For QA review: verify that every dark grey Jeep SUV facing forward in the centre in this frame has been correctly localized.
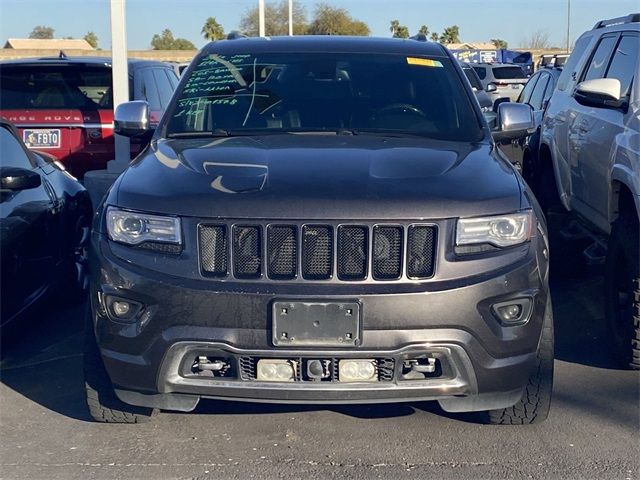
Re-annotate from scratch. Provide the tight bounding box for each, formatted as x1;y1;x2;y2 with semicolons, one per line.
85;36;553;423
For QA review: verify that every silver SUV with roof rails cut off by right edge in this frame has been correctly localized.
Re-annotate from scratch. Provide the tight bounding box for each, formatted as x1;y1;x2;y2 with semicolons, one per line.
537;14;640;368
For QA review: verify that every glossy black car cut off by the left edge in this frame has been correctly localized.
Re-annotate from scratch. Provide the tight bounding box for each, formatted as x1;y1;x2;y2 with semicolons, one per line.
0;119;92;326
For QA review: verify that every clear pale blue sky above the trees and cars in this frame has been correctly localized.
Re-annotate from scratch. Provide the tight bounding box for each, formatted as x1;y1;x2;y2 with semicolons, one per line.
0;0;640;50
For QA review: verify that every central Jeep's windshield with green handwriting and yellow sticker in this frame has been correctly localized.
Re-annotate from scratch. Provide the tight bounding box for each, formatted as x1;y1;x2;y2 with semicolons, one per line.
166;53;482;141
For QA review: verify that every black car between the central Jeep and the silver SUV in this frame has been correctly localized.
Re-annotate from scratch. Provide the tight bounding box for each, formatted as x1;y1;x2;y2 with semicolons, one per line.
500;67;562;185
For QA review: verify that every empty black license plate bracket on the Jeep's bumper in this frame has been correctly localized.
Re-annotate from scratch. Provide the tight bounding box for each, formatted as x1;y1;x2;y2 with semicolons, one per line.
271;300;360;347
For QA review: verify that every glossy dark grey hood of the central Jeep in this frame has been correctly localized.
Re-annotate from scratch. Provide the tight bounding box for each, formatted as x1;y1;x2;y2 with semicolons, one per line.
115;134;521;220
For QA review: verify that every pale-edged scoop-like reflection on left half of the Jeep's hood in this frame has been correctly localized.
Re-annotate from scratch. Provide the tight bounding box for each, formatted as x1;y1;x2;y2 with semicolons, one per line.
202;162;269;193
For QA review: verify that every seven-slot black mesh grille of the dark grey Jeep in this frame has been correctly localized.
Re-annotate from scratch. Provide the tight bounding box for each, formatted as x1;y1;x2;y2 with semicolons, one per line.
198;222;437;282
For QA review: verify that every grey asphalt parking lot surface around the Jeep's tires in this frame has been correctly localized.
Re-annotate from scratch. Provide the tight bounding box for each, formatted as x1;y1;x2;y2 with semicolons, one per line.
0;230;640;480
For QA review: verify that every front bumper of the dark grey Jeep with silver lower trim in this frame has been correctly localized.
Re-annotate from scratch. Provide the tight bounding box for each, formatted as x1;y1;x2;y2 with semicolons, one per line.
92;234;548;411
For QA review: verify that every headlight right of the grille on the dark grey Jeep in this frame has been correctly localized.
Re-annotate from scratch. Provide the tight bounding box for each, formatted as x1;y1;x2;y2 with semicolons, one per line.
456;210;533;247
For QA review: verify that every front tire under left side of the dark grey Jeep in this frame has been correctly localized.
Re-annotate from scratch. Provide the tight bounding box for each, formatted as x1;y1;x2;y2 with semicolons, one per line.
84;307;157;423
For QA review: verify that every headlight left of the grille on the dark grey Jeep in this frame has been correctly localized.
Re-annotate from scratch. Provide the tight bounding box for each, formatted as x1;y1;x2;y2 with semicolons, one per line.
107;207;182;245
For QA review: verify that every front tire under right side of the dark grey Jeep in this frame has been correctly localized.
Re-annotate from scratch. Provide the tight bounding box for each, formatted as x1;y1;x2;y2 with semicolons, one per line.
484;300;554;425
